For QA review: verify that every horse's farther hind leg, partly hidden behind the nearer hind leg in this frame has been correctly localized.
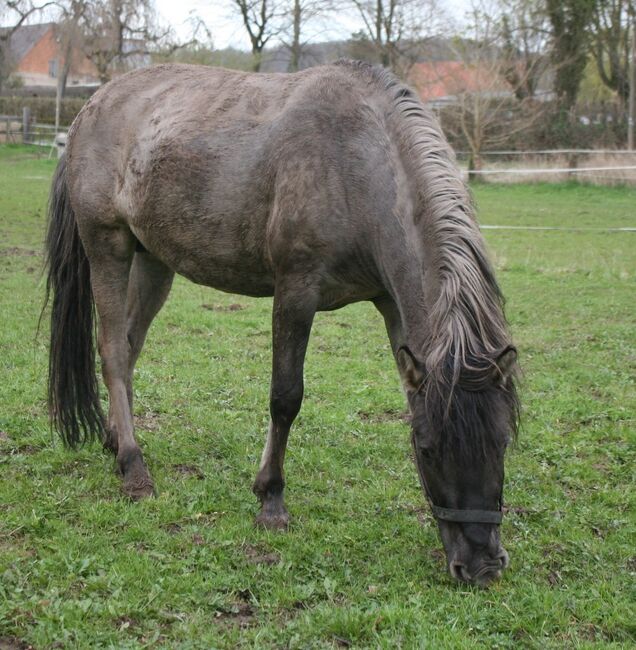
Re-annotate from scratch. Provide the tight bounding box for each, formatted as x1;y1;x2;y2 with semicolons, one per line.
104;251;174;455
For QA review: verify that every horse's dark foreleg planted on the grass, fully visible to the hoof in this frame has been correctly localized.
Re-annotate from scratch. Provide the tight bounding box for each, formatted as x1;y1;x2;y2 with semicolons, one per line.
252;284;316;528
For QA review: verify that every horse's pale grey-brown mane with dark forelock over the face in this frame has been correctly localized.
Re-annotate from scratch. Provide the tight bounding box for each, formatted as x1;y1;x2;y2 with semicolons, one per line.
336;60;519;457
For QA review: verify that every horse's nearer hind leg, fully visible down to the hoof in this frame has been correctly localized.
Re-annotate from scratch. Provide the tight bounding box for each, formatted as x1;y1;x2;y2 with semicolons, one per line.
81;223;154;500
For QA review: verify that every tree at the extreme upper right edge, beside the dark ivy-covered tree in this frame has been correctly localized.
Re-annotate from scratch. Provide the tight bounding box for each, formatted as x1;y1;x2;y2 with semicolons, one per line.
591;0;636;105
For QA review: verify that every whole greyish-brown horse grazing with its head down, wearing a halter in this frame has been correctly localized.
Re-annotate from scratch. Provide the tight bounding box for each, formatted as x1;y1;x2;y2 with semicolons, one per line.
47;61;518;584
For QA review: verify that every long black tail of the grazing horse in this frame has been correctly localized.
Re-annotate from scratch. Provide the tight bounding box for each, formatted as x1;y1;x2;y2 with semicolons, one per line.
45;156;104;447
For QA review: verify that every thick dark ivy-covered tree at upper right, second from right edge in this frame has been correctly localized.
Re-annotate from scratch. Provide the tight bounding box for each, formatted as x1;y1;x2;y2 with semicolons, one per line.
546;0;596;110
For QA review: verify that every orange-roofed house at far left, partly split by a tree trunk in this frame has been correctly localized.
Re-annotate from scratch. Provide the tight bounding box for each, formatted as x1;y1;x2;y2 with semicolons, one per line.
3;23;99;89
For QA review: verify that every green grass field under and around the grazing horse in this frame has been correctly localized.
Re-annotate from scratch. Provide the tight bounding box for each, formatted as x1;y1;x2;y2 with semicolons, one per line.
0;146;636;650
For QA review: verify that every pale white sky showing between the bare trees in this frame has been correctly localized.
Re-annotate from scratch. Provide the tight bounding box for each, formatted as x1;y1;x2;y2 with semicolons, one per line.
155;0;470;50
